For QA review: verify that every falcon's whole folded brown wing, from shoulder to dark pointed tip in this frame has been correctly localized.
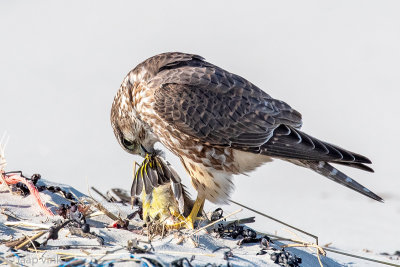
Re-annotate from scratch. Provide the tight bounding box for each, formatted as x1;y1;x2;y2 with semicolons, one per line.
149;54;372;165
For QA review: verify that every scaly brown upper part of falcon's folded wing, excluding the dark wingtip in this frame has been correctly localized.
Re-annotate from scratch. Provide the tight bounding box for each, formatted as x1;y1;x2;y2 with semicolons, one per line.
152;57;301;151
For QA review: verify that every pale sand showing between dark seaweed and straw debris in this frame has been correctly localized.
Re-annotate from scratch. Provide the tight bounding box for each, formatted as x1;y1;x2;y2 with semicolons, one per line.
0;180;400;266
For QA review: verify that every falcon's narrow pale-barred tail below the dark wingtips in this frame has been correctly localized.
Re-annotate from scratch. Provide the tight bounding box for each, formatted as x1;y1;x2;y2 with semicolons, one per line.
299;161;383;202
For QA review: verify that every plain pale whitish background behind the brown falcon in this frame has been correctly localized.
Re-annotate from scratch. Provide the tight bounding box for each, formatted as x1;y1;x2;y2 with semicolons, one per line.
0;0;400;253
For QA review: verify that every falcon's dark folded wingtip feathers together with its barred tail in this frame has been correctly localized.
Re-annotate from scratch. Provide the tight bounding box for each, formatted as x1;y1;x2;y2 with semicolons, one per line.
261;125;383;202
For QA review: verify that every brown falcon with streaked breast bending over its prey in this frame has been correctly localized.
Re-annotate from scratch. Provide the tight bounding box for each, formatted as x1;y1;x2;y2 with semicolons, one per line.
111;52;382;228
